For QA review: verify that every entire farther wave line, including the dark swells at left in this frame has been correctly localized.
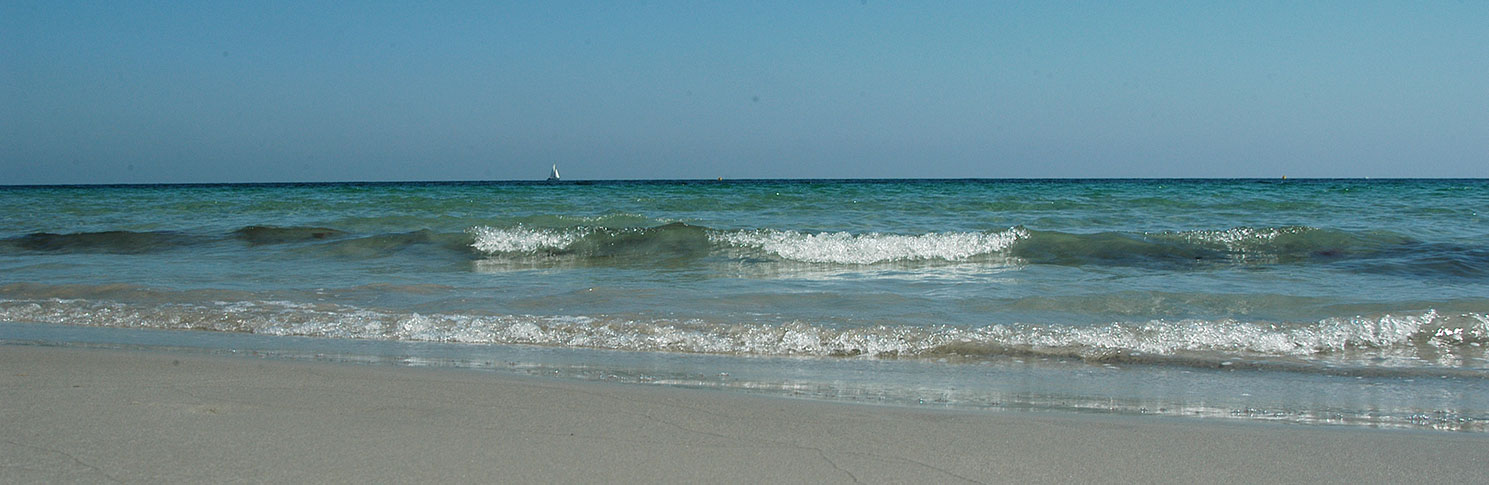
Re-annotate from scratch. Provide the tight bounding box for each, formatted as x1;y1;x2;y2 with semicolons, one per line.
0;223;1489;278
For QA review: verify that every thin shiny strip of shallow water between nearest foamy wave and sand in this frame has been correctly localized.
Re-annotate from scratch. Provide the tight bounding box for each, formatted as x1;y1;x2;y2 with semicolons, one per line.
0;321;1489;431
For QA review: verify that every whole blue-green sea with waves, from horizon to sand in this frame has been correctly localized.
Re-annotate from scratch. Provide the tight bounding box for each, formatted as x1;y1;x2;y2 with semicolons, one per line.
0;179;1489;431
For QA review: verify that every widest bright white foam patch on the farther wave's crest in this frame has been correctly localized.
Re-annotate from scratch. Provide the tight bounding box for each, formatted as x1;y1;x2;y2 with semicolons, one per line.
710;228;1029;265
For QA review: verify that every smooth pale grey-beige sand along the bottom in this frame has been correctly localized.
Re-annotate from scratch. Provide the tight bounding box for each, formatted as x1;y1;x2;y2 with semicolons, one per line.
0;345;1489;484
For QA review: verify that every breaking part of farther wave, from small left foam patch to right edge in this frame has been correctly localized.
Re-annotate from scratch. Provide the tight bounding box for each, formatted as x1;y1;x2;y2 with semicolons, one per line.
468;223;1489;277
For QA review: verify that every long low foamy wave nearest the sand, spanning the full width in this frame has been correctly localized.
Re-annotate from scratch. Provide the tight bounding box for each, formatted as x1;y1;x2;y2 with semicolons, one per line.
0;299;1489;373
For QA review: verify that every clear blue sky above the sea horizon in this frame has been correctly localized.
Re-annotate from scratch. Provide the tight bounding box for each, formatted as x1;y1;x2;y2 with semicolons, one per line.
0;0;1489;184
